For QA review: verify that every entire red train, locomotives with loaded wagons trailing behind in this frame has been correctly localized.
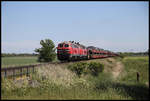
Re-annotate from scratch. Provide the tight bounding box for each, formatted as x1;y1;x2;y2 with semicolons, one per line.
57;41;119;61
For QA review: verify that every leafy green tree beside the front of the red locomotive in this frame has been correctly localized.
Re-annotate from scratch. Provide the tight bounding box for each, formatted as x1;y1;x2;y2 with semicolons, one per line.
35;39;56;62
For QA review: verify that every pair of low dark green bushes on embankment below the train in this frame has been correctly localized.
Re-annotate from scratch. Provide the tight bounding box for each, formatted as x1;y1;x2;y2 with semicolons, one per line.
68;62;104;77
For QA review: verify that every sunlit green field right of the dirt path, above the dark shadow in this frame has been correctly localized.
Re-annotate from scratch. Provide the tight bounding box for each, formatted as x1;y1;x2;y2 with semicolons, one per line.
121;56;149;83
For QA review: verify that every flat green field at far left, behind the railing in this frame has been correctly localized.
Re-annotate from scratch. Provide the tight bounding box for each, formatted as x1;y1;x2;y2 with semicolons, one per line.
1;56;39;68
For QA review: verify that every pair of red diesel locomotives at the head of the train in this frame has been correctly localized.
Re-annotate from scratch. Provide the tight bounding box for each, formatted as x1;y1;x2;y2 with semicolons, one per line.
57;41;87;60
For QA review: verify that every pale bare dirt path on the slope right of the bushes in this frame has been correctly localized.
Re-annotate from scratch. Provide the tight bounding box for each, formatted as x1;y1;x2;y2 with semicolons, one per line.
112;62;123;79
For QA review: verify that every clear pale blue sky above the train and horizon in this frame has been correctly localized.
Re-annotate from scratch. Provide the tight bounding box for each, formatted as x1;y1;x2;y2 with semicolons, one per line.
1;1;149;53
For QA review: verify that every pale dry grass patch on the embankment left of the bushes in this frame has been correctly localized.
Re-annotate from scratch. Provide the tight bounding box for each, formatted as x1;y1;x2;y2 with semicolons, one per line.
37;64;76;86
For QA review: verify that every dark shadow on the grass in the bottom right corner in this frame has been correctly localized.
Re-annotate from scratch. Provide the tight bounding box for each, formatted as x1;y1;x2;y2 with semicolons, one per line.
96;81;149;100
